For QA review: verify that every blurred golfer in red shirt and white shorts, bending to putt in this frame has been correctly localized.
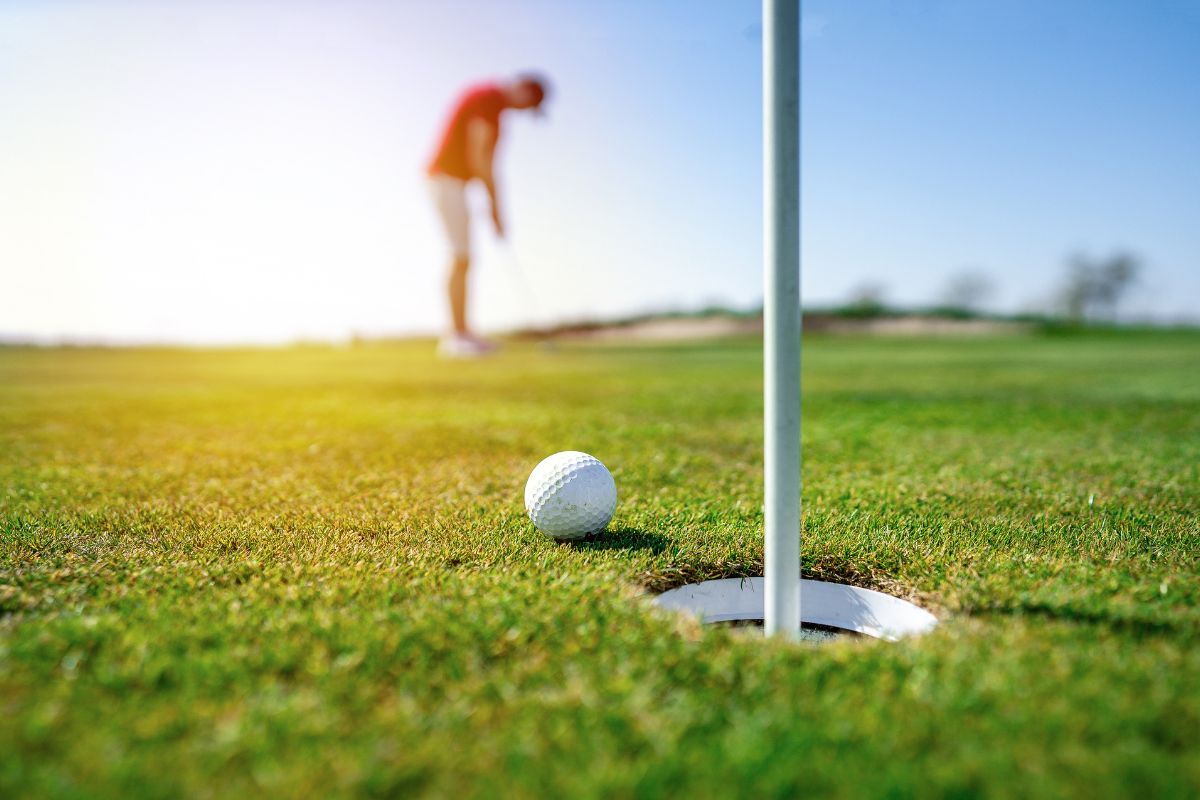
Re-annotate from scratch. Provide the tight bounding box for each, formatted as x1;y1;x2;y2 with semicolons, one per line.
428;76;547;357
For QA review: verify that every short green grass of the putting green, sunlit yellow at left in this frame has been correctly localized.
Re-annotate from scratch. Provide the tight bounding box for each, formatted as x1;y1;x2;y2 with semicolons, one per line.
0;333;1200;798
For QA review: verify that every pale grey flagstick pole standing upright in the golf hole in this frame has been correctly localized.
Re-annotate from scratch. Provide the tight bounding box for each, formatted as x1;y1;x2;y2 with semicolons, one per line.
762;0;800;637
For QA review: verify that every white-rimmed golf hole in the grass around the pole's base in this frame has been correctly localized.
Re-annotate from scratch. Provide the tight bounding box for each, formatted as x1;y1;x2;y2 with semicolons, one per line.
654;578;937;642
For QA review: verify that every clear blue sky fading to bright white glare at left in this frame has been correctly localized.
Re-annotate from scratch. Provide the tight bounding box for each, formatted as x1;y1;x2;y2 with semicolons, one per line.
0;0;1200;342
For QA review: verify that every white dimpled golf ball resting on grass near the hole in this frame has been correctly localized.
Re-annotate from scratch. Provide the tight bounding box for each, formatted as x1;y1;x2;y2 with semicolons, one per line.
526;450;617;540
